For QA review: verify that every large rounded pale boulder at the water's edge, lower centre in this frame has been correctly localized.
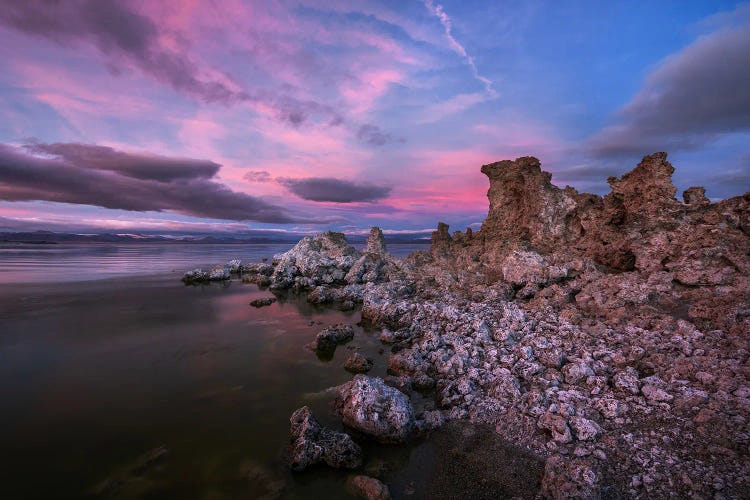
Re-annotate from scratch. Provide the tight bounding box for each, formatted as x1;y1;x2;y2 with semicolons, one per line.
336;375;416;443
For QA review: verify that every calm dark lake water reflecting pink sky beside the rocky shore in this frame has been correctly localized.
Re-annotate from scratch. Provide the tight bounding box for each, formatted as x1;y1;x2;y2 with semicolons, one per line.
0;245;541;499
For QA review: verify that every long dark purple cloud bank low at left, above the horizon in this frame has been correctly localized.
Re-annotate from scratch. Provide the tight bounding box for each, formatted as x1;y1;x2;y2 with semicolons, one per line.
0;144;300;223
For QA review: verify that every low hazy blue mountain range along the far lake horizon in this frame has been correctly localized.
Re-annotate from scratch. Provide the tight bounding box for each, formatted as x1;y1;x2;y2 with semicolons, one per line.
0;231;429;245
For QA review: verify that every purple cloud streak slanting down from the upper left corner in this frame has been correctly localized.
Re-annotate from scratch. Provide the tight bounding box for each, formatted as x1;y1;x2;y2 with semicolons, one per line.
0;0;344;126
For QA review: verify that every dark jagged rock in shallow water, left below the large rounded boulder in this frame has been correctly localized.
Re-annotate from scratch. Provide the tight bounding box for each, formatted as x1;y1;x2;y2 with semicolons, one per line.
289;406;362;471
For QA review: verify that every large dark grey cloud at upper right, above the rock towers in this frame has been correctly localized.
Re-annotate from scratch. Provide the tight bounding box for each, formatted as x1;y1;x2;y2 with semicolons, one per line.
591;24;750;156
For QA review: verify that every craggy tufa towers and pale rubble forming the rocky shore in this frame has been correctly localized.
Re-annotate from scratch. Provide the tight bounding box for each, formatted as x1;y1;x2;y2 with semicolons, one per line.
207;153;750;498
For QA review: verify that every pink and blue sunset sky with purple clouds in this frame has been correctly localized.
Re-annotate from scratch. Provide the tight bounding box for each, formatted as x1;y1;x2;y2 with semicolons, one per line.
0;0;750;234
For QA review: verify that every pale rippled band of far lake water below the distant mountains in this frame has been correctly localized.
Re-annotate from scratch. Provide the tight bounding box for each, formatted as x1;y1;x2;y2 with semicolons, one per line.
0;243;428;283
